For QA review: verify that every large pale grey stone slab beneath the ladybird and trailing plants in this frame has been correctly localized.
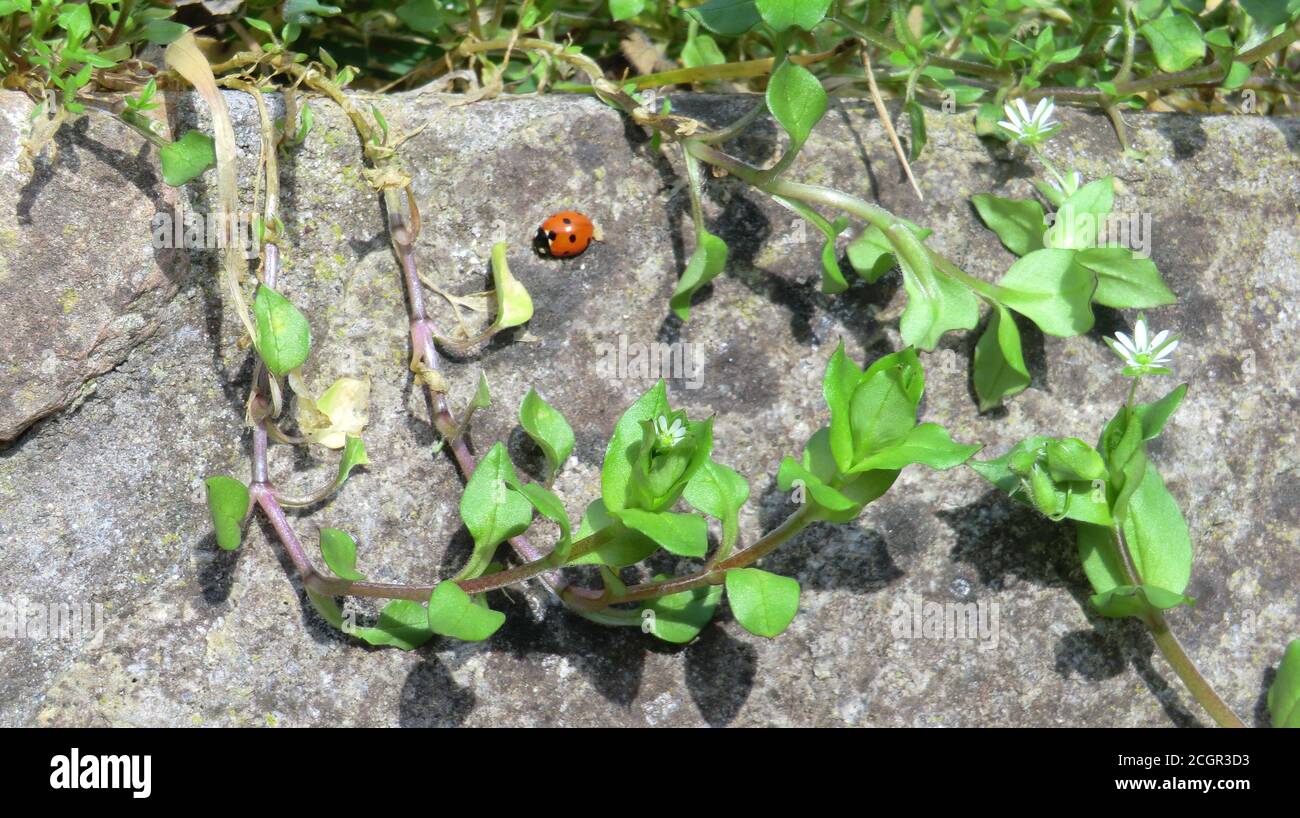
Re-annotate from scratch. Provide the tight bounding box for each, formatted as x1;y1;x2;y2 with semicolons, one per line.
0;89;1300;726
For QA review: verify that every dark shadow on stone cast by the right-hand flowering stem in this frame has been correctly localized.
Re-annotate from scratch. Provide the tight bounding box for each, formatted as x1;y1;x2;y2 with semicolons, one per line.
935;490;1203;727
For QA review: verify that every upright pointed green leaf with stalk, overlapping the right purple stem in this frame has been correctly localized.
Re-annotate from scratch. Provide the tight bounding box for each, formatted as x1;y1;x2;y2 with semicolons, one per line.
456;442;533;580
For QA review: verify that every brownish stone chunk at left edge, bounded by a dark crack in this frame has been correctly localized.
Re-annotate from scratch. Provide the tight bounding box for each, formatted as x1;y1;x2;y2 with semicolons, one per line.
0;94;187;443
